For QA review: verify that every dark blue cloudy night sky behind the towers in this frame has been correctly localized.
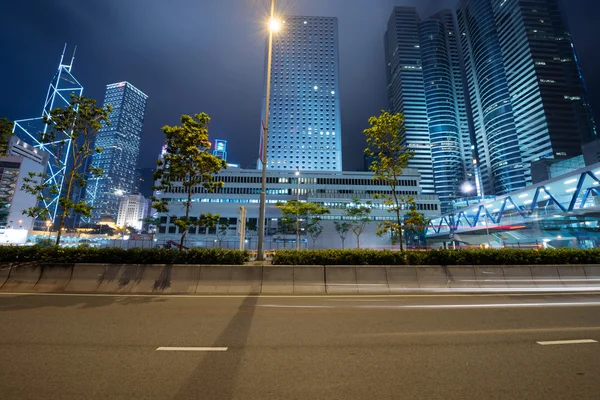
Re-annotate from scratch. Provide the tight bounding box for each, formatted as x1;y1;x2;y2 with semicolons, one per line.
0;0;600;170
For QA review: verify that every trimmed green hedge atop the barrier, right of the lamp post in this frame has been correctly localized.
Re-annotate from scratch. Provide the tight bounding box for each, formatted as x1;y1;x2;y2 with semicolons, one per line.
273;249;600;265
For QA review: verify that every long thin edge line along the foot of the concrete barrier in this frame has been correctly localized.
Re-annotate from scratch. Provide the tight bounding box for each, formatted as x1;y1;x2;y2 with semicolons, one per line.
0;288;600;299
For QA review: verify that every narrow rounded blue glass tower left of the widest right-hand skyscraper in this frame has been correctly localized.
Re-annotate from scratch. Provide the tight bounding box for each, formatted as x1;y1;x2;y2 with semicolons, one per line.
419;10;473;211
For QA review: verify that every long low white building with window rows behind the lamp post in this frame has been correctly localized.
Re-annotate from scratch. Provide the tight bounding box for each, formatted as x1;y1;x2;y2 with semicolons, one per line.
156;169;440;249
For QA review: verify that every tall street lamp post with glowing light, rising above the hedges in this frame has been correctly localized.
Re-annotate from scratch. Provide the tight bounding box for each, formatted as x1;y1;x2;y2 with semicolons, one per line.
256;0;275;261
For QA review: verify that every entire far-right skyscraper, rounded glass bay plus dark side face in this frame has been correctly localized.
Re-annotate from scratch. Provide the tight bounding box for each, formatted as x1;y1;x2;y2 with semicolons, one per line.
457;0;596;194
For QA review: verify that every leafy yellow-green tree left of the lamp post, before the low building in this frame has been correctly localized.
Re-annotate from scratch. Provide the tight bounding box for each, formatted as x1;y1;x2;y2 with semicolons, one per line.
152;113;227;249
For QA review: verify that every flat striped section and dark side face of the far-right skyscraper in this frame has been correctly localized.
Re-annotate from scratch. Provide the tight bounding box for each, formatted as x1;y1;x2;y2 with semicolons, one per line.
491;0;596;183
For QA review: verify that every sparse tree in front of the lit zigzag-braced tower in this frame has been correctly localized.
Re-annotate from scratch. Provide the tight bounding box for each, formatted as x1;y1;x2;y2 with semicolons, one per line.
22;95;112;246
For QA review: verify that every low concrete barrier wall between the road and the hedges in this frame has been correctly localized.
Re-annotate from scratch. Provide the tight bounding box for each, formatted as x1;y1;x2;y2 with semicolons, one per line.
0;264;600;295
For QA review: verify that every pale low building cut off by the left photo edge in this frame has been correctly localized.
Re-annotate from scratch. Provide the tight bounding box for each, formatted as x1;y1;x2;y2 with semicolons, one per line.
0;136;49;233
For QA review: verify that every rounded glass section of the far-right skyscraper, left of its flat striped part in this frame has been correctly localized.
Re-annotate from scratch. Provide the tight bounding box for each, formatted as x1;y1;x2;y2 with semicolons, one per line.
457;0;526;195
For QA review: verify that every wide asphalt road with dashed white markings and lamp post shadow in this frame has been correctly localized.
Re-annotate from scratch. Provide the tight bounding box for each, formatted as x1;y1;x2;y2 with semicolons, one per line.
0;294;600;400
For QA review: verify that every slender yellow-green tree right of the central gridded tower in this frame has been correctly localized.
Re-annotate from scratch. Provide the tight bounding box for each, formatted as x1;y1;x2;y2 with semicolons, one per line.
364;111;414;251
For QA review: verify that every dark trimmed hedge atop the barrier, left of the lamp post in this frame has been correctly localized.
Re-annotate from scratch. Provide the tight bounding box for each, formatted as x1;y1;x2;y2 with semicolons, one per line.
0;246;250;265
